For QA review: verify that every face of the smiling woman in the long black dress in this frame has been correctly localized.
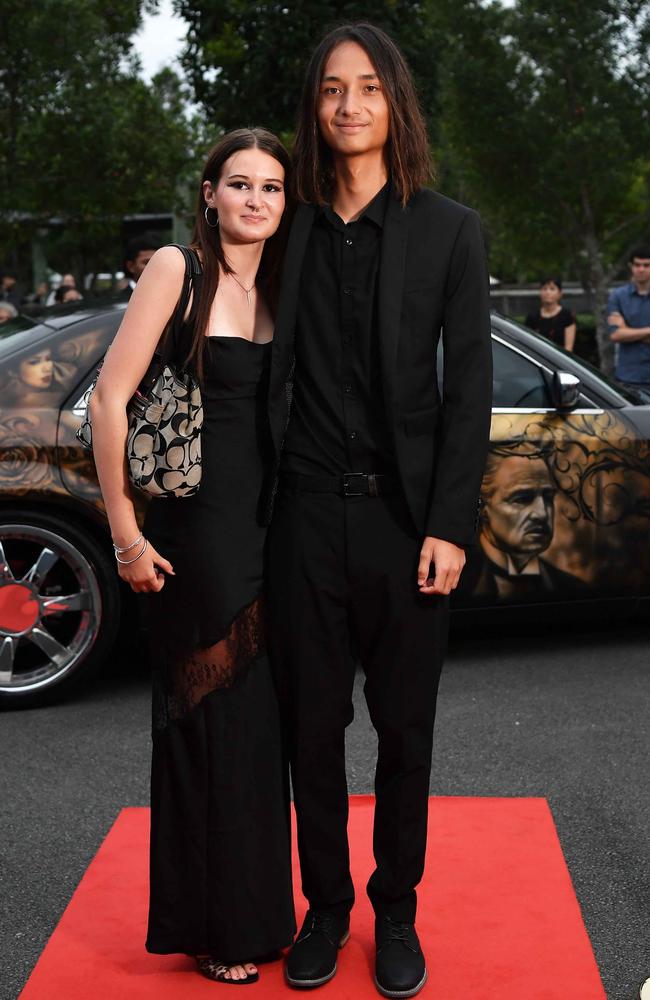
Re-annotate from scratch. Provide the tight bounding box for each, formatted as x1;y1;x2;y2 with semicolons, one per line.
203;149;285;243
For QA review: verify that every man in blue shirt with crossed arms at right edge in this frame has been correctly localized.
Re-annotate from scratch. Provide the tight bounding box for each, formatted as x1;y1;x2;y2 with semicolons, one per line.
607;246;650;393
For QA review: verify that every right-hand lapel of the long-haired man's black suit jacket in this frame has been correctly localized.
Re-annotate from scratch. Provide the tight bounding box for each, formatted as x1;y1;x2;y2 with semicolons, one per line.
377;192;410;412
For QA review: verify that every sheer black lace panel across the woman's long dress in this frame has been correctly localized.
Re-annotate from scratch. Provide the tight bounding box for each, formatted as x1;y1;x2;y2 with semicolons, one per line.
153;598;266;730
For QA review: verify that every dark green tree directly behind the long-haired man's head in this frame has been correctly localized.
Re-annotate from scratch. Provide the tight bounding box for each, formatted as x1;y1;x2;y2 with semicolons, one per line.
174;0;443;140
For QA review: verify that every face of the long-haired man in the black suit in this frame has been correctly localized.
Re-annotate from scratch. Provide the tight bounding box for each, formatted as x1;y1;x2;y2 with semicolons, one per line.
318;42;389;156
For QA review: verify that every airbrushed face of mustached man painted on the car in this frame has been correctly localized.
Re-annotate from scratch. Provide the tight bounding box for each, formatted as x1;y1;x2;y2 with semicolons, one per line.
482;457;557;557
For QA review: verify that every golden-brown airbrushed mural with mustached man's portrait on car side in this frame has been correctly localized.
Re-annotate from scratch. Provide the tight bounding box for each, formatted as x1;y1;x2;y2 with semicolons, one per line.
462;411;650;604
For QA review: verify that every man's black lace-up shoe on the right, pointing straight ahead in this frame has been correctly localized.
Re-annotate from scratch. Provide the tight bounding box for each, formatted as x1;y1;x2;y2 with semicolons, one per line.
375;916;427;998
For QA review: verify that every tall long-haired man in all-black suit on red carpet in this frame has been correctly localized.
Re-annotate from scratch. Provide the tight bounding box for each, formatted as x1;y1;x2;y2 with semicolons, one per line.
269;24;492;997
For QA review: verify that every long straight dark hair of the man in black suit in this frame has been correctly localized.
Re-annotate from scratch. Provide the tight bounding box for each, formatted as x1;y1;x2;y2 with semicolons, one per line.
293;22;432;205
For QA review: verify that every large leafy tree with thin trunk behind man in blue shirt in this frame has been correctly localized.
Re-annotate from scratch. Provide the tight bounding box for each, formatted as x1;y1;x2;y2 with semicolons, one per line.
441;0;650;370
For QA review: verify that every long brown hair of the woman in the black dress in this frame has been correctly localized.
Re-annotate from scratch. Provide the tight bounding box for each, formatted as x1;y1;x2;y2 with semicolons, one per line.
187;128;291;379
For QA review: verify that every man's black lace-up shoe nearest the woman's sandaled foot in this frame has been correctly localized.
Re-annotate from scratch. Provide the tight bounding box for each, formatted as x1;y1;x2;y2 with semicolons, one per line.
285;910;350;990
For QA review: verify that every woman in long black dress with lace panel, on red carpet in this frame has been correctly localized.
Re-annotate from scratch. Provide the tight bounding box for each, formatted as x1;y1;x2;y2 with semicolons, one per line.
91;129;295;984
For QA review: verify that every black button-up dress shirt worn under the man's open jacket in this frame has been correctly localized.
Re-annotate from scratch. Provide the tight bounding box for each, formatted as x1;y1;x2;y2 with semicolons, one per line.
281;184;394;476
